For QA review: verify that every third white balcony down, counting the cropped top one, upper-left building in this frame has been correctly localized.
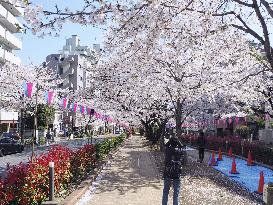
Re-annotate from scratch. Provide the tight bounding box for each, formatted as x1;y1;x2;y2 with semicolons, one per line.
0;25;22;50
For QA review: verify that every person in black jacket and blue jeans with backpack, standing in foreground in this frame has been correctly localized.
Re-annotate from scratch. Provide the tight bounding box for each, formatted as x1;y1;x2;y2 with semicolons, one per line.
162;133;183;205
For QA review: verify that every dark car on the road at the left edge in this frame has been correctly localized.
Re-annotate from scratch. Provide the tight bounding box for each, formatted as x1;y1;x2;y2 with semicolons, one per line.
0;137;24;156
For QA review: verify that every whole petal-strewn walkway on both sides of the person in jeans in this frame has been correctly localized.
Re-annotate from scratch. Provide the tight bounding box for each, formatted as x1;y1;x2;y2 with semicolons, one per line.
75;136;263;205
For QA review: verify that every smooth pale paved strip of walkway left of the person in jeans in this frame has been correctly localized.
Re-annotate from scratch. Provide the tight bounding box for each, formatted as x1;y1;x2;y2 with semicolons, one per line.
83;136;162;205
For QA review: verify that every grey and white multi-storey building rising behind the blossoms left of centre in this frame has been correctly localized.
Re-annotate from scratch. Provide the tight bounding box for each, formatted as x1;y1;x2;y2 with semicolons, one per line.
46;35;100;127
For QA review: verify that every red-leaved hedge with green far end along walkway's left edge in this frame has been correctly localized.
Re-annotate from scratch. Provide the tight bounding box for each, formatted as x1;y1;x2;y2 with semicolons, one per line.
0;135;125;205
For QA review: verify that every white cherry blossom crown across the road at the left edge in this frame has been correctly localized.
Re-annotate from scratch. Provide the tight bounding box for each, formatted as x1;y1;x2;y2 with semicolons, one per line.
0;63;62;109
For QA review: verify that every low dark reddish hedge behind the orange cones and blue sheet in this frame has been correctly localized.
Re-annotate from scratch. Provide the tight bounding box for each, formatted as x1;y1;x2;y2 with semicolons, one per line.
181;135;273;166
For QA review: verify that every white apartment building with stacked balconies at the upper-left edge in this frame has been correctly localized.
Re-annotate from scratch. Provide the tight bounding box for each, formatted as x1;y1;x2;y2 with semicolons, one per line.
0;0;24;65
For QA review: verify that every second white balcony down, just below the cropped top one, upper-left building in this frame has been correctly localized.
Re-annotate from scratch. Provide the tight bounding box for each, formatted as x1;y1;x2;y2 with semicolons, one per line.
0;5;23;33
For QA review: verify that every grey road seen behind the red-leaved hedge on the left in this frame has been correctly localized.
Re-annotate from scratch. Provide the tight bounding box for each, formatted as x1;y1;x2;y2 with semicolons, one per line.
0;135;113;178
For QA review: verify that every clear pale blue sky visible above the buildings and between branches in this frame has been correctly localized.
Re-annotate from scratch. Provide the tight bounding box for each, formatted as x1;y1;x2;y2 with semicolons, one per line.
16;0;273;65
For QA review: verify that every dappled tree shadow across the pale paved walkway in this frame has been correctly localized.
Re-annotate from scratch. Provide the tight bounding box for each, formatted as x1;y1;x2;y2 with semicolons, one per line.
91;144;162;195
